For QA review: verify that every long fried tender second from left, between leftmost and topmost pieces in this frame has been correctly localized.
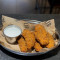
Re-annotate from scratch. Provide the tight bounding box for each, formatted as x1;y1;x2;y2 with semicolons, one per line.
22;29;35;50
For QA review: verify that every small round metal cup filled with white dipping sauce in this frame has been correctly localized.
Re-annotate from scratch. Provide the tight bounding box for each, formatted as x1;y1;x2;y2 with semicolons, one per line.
3;25;22;44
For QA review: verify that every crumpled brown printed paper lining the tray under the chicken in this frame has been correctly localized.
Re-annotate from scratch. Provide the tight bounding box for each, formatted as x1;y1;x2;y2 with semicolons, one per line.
0;15;58;53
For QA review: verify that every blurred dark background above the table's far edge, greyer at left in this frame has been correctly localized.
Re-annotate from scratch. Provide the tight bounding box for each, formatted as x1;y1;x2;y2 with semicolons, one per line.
0;0;60;14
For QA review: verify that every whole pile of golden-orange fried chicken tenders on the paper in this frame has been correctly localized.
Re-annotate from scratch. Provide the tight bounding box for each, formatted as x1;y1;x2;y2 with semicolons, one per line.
18;24;55;52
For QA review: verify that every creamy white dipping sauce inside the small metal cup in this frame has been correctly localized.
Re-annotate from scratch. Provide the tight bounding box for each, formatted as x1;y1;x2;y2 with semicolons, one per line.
4;25;21;37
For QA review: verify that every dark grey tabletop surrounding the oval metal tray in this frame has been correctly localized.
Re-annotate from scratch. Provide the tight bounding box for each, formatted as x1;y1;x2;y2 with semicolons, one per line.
0;14;60;60
